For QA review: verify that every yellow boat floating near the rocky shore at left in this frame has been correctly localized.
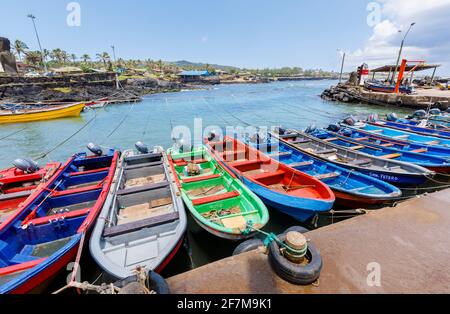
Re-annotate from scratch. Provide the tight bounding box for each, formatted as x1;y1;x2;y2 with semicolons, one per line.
0;103;85;124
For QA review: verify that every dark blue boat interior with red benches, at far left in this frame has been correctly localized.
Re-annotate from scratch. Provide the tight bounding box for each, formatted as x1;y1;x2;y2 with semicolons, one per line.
0;155;112;285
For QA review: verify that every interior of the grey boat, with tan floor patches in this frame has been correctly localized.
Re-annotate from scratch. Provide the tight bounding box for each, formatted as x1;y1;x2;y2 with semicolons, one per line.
103;153;179;238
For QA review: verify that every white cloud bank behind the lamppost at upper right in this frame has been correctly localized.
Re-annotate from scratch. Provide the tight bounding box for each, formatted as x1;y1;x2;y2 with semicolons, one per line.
348;0;450;75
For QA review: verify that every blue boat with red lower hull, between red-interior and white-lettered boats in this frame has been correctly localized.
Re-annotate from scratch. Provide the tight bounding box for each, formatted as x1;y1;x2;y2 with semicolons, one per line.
246;133;401;208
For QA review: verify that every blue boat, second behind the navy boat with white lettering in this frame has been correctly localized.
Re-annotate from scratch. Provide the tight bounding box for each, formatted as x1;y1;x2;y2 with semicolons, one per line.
328;126;450;160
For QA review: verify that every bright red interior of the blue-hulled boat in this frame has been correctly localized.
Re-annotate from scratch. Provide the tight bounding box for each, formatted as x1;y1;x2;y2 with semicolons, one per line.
209;138;328;199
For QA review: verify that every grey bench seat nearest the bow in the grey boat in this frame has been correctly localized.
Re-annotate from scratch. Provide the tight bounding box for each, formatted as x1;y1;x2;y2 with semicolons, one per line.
103;212;180;237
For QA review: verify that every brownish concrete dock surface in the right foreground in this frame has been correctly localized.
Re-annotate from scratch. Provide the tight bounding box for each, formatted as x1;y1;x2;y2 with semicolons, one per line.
168;190;450;294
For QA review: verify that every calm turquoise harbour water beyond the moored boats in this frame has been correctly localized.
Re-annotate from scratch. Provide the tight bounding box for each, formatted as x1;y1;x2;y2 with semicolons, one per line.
0;81;408;168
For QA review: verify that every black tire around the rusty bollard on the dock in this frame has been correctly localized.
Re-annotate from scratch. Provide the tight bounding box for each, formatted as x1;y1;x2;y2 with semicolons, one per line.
269;233;322;286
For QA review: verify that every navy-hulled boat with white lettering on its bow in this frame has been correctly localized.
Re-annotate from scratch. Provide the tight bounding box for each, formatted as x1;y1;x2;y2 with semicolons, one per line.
279;130;433;187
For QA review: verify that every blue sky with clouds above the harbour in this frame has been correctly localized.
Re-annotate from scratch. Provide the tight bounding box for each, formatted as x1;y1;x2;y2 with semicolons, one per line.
0;0;450;75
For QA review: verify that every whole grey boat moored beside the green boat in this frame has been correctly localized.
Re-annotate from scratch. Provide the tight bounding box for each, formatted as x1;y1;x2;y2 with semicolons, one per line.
89;143;187;279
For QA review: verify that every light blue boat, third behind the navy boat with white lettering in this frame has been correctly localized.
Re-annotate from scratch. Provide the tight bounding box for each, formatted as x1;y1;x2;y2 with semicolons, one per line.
357;123;450;147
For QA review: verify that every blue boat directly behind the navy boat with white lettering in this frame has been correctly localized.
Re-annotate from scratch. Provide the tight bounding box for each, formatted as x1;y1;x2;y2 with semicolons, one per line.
311;129;450;177
